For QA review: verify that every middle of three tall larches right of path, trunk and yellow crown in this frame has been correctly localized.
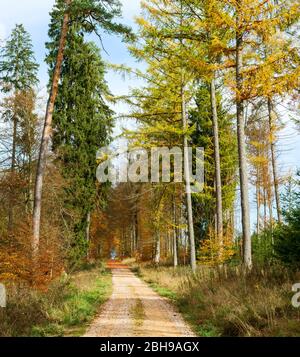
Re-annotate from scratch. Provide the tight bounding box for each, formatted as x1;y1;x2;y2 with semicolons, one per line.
175;0;231;254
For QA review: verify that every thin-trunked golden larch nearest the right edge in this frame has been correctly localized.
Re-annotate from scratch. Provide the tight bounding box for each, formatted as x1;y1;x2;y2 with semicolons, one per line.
261;0;300;223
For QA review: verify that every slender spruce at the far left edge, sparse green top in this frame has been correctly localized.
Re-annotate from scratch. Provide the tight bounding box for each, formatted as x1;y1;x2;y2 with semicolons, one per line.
0;25;38;232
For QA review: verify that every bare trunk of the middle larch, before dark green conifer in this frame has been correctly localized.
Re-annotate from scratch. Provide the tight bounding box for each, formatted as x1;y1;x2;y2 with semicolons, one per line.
210;78;223;251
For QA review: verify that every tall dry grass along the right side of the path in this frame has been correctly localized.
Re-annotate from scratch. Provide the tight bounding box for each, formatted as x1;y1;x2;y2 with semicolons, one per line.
133;264;300;336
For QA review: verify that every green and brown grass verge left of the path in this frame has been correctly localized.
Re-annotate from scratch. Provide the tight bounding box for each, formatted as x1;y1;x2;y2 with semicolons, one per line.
0;265;112;337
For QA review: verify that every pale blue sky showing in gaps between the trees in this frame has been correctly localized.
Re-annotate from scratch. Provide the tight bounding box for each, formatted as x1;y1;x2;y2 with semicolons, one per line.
0;0;300;229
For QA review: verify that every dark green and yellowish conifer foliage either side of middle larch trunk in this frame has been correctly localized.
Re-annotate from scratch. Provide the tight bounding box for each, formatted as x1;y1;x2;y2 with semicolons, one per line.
189;84;237;245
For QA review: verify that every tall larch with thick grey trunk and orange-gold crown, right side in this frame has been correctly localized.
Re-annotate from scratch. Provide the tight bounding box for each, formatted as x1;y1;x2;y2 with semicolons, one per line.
229;0;299;269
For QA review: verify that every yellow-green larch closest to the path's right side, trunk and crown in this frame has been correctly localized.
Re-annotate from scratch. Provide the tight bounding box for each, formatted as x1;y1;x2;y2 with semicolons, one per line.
125;1;196;271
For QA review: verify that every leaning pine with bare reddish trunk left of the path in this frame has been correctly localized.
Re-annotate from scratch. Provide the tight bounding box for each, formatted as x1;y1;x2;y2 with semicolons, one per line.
32;0;130;257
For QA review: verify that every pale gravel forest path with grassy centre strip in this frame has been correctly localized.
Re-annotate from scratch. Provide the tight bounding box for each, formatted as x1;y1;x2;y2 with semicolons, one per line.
84;262;194;337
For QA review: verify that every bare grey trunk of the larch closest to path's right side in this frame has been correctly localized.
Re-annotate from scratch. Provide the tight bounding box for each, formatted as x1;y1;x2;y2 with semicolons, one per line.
181;81;197;272
